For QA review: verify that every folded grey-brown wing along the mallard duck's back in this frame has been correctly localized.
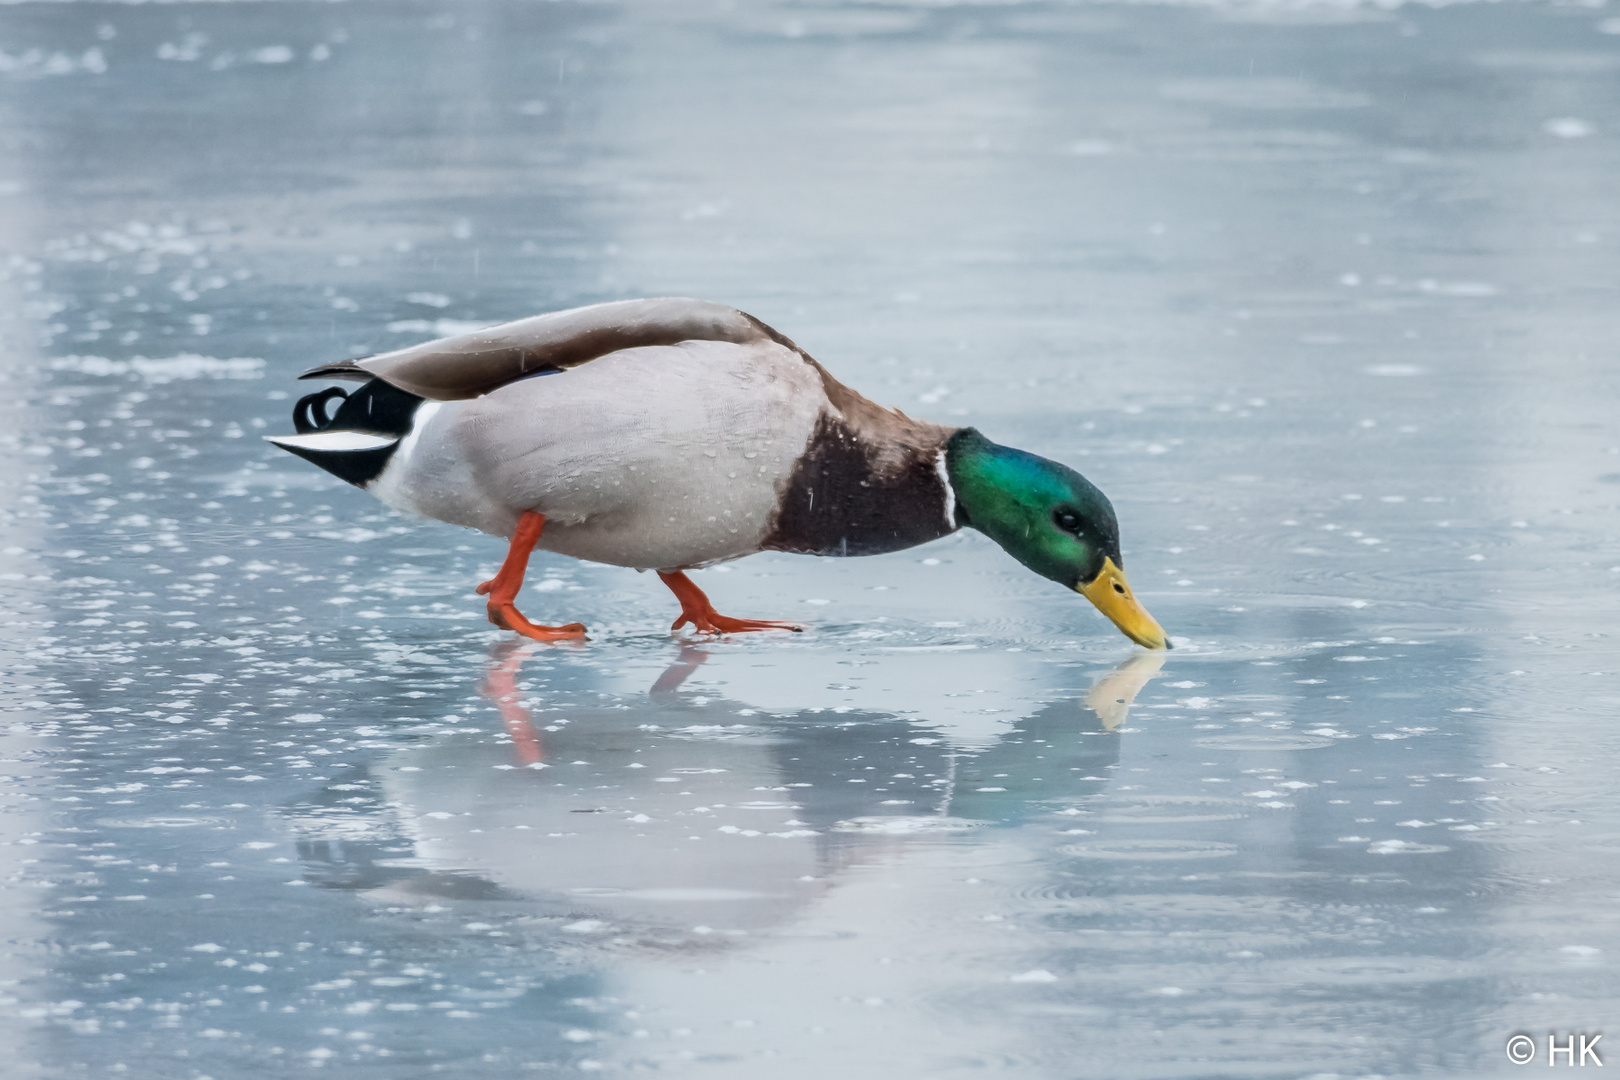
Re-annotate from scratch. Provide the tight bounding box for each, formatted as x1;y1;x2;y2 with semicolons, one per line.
300;296;802;402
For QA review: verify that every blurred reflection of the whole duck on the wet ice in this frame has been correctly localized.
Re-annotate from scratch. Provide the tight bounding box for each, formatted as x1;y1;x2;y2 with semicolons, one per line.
281;643;1163;933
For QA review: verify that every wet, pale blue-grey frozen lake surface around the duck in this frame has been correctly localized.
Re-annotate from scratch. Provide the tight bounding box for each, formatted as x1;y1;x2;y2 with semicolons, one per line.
0;0;1620;1080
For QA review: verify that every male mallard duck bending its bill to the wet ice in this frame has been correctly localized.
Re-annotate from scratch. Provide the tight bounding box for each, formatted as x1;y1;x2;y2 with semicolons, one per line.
269;298;1170;649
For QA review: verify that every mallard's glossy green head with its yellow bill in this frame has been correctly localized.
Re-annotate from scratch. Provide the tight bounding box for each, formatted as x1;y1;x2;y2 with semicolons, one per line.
944;427;1170;649
